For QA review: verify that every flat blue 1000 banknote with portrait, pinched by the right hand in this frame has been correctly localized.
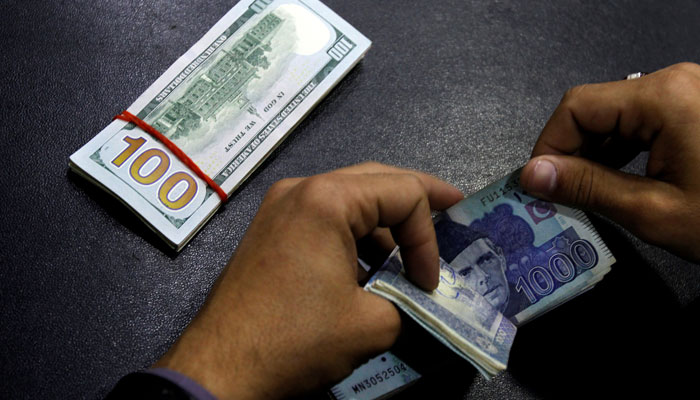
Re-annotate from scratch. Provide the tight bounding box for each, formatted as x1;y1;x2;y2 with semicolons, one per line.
435;171;615;324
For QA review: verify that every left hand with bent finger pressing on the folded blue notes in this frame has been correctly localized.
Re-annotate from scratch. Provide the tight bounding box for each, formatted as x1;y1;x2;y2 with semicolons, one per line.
155;163;462;399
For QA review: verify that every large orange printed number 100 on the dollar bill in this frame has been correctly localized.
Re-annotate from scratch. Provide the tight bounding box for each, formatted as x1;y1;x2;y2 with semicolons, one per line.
112;136;197;210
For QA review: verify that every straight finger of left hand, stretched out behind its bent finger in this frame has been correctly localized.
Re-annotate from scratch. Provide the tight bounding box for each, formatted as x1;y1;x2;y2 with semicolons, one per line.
332;162;464;210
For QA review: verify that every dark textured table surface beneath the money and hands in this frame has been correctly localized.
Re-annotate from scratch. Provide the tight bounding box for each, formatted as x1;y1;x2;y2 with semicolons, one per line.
0;0;700;399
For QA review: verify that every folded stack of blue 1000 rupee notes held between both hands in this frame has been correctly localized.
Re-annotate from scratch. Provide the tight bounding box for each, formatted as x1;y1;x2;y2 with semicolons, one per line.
365;171;615;377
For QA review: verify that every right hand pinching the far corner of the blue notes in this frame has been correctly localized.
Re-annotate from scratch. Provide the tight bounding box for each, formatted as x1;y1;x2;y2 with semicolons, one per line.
521;63;700;262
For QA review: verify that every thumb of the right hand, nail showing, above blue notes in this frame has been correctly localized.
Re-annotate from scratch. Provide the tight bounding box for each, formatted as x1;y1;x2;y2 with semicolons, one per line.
520;155;677;244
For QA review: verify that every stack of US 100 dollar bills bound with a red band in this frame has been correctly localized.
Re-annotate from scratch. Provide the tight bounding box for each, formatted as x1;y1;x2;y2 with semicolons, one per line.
70;0;371;250
